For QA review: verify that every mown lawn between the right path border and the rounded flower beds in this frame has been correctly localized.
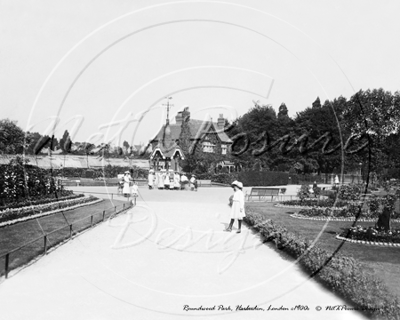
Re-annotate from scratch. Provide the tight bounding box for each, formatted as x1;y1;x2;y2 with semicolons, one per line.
246;202;400;298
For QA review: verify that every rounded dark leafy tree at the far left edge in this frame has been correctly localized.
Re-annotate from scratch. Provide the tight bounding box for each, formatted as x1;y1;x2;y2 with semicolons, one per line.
0;119;30;154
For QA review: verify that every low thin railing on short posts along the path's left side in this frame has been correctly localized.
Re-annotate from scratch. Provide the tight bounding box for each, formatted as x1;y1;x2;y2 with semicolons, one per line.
0;203;131;279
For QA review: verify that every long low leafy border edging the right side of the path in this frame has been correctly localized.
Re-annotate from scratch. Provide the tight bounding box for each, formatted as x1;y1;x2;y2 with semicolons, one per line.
244;210;400;319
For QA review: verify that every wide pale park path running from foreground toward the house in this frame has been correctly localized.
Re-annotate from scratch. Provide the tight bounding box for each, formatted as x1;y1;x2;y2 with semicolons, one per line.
0;187;363;320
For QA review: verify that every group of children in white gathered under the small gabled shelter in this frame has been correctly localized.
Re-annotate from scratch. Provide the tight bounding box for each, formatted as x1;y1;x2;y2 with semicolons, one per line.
148;169;197;191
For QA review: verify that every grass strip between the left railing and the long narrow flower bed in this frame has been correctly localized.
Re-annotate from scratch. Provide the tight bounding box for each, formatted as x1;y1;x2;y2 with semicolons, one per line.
0;200;127;276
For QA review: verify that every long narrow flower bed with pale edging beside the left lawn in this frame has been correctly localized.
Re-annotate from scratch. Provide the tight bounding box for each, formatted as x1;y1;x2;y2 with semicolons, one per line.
0;195;101;226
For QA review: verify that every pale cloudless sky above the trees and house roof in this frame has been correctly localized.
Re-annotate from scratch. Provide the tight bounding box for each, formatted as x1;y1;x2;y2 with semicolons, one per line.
0;0;400;145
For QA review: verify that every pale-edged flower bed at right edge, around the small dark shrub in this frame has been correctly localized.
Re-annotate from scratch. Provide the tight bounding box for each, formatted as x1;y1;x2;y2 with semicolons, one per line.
339;226;400;244
